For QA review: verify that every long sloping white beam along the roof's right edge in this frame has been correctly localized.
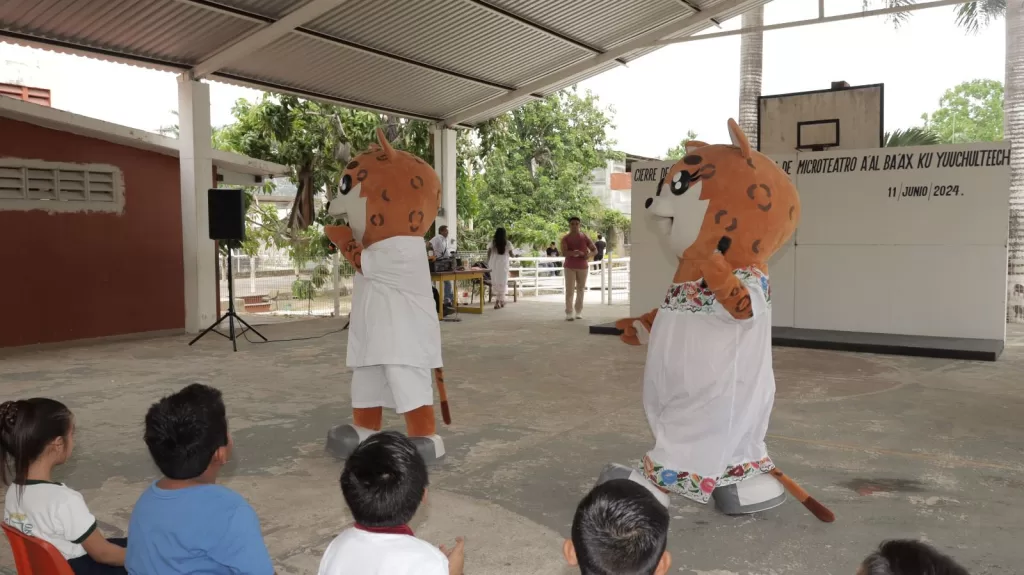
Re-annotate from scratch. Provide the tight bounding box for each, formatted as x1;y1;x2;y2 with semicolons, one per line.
444;0;753;126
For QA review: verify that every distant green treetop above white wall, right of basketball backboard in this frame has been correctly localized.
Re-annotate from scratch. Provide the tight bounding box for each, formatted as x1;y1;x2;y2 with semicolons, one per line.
925;80;1002;143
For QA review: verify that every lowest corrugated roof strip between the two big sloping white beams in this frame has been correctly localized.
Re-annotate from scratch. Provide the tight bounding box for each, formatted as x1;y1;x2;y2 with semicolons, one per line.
224;34;503;118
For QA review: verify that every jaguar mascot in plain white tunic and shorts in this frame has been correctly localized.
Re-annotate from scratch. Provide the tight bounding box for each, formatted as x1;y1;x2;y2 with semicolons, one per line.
325;129;451;463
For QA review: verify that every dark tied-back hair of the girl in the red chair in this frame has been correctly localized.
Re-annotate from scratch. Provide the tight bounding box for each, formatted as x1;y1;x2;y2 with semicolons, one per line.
0;397;73;486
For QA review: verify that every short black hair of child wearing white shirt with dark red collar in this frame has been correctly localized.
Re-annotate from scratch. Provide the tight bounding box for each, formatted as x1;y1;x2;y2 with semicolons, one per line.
341;432;429;527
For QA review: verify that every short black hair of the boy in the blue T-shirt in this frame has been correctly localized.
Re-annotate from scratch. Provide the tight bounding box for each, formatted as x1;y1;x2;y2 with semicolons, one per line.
145;384;227;480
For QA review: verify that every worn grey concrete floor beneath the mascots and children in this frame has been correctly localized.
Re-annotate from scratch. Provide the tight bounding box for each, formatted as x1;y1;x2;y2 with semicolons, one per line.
0;302;1024;575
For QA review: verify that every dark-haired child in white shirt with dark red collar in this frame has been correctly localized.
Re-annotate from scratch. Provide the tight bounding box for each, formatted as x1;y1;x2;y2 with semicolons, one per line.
319;432;465;575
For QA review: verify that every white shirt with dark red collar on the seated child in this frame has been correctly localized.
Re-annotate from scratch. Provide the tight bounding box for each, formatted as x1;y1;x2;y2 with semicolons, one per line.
318;528;449;575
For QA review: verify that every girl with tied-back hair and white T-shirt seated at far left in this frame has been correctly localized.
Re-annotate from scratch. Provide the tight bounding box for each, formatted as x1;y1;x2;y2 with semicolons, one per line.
0;397;127;575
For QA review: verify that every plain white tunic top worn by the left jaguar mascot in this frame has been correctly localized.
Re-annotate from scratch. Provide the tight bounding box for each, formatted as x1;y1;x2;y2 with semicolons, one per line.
347;235;442;369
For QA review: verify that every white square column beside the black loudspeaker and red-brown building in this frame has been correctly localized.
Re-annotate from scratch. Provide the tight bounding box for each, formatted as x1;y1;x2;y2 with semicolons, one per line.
178;76;217;334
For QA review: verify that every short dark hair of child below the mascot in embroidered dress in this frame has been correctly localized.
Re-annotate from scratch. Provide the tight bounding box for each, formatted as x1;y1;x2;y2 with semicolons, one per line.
572;479;669;575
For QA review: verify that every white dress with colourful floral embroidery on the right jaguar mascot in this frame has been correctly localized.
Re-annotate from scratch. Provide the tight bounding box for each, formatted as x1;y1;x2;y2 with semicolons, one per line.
643;267;775;503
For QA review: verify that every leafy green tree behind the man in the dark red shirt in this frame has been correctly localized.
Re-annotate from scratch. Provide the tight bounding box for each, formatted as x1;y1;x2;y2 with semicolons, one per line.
468;87;621;250
